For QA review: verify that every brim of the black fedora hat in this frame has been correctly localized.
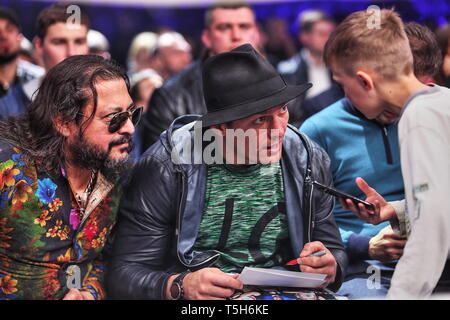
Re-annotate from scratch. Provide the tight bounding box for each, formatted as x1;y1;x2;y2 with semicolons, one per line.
199;83;312;128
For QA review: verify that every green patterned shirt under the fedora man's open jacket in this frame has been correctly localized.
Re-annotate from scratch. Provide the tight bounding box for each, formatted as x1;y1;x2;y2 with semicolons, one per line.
194;162;288;272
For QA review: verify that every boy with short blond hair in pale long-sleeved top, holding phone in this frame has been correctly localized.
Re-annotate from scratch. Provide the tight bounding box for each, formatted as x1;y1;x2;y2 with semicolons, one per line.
325;9;450;299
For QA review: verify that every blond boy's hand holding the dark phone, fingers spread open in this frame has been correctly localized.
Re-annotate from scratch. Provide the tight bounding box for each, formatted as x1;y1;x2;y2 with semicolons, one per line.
339;177;396;224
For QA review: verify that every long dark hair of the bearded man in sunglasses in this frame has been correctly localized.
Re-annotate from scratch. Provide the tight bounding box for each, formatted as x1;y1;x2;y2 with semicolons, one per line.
0;55;130;170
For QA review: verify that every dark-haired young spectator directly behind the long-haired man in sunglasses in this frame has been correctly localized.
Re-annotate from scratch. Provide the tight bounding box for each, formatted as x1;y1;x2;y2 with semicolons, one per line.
24;4;89;100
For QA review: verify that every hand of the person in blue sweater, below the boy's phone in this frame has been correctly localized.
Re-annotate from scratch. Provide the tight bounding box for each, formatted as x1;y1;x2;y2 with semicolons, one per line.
369;226;406;261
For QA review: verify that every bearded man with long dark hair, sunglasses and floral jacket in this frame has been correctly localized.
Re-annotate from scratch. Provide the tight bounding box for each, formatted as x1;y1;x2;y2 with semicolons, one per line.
0;55;142;299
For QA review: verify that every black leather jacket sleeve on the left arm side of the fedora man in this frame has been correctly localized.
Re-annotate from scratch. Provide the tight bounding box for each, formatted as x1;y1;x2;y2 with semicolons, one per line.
107;151;177;299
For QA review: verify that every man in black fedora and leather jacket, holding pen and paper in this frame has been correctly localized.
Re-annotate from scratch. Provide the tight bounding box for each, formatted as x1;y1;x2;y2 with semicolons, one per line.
107;44;347;300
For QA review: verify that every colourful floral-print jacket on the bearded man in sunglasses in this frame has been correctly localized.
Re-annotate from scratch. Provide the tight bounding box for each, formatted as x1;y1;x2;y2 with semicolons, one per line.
0;142;119;299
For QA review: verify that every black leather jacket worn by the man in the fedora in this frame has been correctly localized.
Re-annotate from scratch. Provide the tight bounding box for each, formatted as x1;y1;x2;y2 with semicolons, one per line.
107;116;347;299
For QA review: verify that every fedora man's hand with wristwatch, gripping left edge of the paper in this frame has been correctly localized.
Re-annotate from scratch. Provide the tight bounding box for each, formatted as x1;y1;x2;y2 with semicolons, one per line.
166;268;243;300
